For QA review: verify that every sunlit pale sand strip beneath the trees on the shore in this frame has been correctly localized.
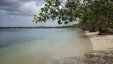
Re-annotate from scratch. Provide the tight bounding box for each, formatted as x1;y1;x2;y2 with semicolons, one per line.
86;32;113;50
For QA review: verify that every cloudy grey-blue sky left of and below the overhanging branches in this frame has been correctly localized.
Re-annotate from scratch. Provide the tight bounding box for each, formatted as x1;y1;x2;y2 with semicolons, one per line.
0;0;58;27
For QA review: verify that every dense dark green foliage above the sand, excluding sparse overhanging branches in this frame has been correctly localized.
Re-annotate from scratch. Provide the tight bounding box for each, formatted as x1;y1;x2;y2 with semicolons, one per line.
80;0;113;29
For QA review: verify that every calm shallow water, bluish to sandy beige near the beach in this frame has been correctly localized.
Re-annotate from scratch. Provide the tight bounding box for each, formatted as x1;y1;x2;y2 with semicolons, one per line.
0;28;92;64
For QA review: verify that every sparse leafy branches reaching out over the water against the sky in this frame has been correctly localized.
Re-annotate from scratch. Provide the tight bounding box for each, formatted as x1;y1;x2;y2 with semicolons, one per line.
33;0;80;24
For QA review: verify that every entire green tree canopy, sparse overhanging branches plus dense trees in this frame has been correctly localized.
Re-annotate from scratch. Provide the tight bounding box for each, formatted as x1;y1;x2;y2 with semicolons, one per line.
33;0;113;34
